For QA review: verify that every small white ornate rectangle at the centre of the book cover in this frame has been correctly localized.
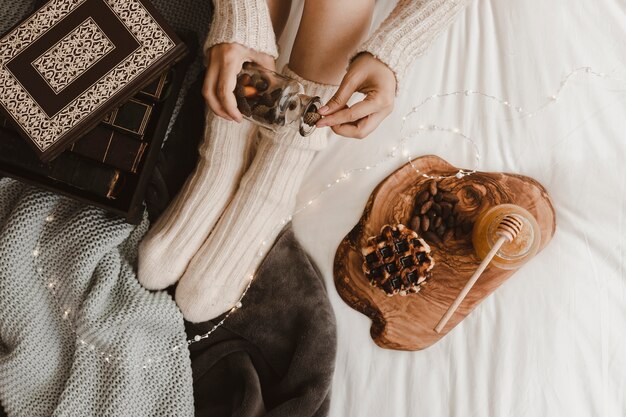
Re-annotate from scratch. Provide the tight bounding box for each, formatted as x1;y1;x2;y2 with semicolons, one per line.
33;18;115;94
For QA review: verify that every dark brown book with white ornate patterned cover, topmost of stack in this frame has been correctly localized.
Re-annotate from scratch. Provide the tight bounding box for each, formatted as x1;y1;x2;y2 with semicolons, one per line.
0;0;186;160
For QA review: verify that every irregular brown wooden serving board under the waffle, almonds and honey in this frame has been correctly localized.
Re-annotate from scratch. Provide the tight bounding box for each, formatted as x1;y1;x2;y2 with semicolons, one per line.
334;156;556;350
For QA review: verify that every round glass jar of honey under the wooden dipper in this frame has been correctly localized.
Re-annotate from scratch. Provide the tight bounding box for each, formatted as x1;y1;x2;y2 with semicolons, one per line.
472;204;541;269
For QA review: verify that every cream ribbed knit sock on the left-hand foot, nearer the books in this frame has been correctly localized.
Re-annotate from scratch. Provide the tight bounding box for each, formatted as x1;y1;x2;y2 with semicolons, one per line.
138;112;253;290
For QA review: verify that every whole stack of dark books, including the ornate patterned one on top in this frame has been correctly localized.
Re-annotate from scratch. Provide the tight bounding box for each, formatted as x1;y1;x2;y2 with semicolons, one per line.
0;0;187;223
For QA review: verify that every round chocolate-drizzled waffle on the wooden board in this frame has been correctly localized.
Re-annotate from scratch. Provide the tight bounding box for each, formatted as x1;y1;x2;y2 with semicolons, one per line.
361;224;435;297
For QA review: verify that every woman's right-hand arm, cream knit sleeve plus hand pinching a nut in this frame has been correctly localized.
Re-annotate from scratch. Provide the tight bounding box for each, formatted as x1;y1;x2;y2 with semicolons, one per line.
318;0;471;138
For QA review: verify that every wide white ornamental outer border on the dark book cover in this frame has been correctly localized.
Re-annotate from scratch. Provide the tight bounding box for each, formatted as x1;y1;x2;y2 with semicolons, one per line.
0;0;175;151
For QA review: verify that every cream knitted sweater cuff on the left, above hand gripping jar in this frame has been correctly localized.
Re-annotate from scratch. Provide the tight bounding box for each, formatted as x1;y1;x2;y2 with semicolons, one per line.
204;0;278;58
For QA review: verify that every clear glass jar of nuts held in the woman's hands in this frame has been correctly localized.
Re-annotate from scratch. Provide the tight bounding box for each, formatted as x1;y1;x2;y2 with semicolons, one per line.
235;62;322;136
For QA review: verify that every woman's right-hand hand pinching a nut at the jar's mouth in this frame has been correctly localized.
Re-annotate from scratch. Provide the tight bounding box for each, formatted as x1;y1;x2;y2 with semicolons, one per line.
317;53;396;139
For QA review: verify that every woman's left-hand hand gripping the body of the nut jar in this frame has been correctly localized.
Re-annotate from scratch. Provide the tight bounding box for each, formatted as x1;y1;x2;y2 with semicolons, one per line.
202;43;276;122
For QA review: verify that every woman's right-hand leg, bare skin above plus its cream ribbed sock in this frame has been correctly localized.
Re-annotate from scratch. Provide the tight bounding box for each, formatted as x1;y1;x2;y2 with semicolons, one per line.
176;0;373;322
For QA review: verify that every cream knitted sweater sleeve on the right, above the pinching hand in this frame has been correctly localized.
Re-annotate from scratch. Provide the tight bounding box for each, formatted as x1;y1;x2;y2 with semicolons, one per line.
355;0;470;85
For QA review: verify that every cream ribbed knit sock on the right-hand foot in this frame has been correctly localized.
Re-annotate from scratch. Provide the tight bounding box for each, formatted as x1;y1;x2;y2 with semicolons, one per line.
176;68;336;323
